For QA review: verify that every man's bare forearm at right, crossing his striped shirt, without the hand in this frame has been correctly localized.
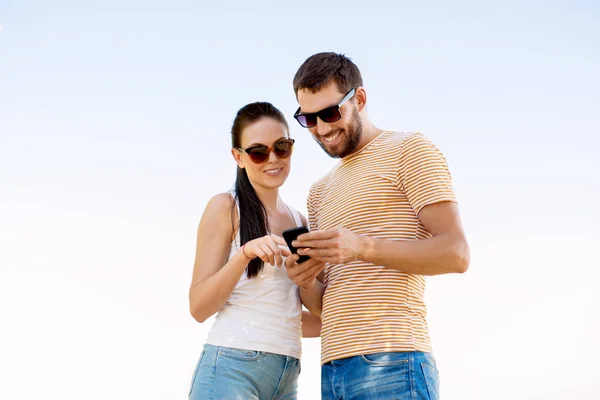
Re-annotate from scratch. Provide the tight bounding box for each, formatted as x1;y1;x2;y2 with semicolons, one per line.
358;233;469;275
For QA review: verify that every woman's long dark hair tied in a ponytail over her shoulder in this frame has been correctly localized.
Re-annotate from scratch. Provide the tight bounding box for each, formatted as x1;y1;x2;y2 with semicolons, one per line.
231;102;289;278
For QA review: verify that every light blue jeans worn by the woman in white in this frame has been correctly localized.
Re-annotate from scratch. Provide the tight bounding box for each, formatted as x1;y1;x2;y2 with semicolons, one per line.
189;344;300;400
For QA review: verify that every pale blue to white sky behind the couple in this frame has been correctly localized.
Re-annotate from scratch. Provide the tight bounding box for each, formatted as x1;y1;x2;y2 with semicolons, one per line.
0;0;600;400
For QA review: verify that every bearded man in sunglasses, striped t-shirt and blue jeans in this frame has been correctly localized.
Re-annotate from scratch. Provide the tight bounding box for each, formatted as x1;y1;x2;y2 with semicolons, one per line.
287;53;469;400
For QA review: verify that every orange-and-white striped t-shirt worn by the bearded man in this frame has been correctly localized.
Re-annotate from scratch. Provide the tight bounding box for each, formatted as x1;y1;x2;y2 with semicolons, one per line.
307;131;456;364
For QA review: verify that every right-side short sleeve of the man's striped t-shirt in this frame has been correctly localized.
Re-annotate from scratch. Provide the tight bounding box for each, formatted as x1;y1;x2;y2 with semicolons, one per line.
397;133;456;215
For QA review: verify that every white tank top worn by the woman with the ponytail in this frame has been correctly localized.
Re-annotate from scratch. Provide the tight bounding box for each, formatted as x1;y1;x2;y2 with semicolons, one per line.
206;194;302;359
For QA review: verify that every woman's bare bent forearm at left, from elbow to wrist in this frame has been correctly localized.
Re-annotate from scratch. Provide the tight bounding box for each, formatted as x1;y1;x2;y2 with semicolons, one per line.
190;251;248;322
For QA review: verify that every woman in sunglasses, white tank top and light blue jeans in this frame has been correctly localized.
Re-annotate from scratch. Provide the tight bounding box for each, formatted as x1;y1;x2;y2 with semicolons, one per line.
190;102;324;400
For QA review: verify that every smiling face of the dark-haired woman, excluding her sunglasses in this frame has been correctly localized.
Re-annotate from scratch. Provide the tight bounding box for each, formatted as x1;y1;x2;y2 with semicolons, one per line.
232;117;291;189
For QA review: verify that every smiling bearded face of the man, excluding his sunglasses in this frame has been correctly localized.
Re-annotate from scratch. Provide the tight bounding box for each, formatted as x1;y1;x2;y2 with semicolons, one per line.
298;83;362;158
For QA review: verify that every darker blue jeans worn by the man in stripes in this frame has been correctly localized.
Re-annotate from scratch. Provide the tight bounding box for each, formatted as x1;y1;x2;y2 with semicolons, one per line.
321;351;439;400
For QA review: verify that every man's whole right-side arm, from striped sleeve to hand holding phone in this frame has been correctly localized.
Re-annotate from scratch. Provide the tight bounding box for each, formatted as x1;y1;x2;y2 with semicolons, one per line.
293;134;469;275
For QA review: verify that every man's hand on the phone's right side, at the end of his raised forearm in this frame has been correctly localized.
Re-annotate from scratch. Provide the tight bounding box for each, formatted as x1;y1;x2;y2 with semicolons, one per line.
292;228;363;264
